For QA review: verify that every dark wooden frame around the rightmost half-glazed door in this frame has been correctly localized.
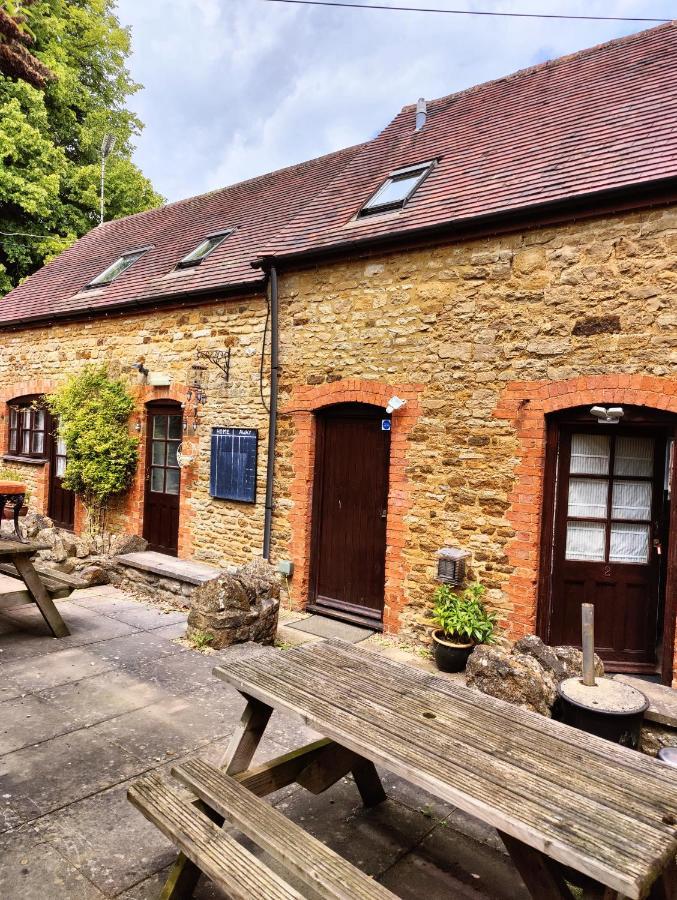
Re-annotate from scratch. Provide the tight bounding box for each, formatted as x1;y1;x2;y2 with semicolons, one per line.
536;403;677;685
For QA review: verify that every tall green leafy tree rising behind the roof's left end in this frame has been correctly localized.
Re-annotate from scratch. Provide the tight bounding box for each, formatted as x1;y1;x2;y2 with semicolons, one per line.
0;0;162;294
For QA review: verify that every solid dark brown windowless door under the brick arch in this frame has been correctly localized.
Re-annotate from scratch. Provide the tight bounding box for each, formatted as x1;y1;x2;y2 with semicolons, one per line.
310;404;390;625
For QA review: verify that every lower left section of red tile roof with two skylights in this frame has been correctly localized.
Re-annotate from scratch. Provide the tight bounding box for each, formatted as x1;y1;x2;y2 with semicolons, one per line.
0;146;361;327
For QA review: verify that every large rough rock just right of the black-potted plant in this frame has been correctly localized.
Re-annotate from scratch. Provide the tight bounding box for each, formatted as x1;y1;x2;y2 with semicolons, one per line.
465;644;557;716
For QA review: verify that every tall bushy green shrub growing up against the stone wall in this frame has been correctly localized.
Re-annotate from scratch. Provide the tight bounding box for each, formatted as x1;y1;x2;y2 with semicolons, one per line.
45;366;139;534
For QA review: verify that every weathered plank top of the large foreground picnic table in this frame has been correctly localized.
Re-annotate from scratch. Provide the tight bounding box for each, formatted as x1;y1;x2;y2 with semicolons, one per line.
214;641;677;900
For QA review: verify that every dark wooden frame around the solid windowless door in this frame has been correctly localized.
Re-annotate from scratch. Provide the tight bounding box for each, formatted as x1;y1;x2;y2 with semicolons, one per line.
307;401;391;631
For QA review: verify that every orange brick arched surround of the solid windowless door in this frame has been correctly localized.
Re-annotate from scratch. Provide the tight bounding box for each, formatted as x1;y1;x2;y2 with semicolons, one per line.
281;378;423;632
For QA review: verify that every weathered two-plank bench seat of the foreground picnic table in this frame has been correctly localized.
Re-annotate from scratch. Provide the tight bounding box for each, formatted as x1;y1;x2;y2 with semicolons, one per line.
127;759;394;900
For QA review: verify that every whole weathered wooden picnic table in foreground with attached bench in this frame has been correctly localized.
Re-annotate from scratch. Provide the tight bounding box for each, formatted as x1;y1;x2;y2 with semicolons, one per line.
130;641;677;900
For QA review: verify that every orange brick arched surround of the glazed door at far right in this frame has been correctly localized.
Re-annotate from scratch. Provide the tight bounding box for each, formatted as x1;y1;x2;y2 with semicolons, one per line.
494;374;677;639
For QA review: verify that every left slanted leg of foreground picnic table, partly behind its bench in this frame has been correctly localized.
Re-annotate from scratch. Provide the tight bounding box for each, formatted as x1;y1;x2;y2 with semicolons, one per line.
160;697;273;900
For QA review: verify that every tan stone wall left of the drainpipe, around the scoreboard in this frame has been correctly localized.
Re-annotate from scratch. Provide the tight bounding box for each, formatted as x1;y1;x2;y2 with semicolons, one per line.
0;297;268;566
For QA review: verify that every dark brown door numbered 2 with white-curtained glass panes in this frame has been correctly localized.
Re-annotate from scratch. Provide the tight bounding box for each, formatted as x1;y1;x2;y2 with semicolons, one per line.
548;425;666;672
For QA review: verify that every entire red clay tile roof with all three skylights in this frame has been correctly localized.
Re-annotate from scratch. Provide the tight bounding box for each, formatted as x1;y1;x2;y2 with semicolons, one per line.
0;22;677;327
